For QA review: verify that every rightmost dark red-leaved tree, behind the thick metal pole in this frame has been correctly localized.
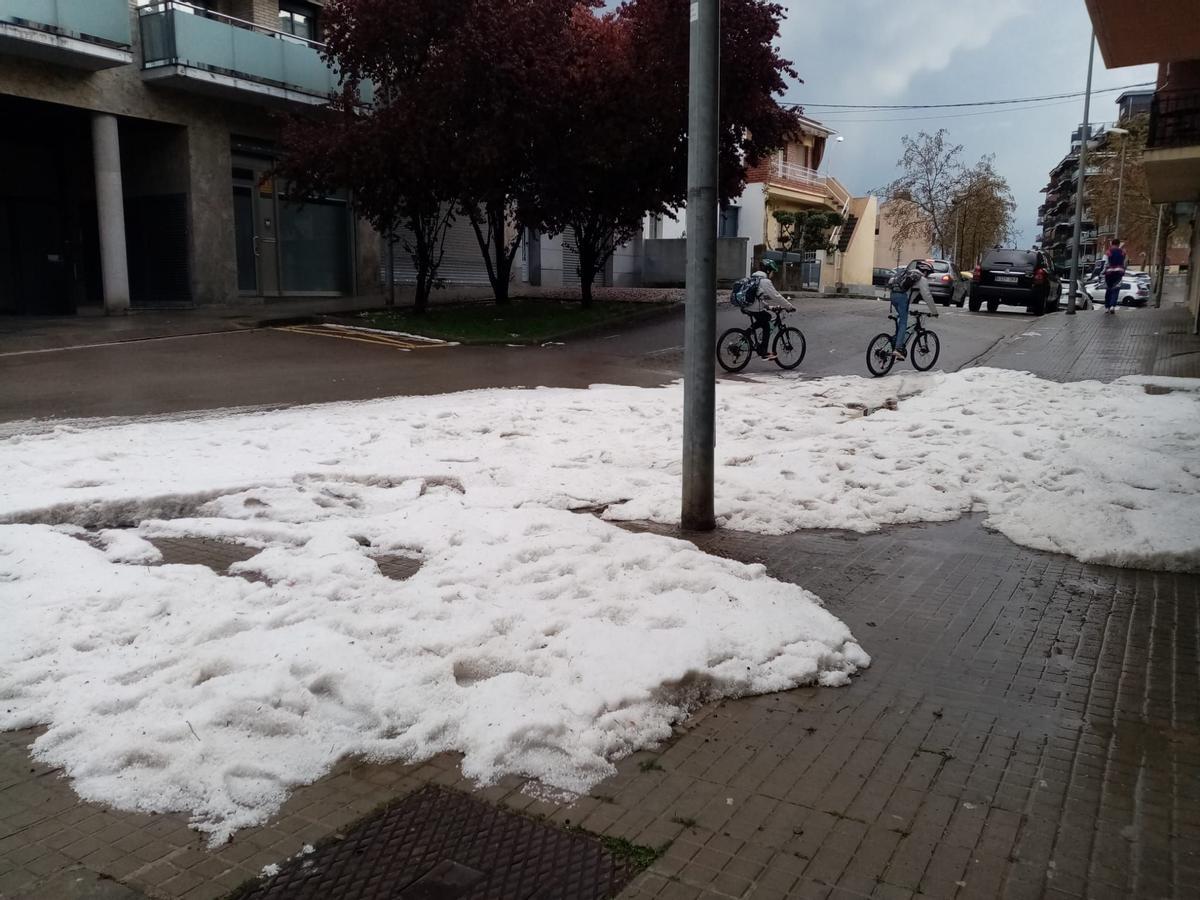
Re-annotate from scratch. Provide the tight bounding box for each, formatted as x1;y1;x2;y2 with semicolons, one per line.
533;0;798;305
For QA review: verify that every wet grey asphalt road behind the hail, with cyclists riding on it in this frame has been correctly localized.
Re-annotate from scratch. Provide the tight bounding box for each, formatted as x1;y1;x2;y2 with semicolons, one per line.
0;298;1038;422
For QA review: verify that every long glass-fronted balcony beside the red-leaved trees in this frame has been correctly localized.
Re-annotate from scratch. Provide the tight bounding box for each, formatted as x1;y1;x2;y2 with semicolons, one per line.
140;0;348;103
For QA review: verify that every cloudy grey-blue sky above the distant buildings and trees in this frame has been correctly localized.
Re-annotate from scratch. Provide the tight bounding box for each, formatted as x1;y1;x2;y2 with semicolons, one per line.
781;0;1156;244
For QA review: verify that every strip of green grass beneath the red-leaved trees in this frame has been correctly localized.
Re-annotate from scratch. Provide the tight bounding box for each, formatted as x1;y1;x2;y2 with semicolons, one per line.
354;299;673;343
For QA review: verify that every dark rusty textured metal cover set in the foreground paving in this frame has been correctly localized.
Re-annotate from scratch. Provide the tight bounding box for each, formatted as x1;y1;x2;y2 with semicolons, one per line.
231;787;636;900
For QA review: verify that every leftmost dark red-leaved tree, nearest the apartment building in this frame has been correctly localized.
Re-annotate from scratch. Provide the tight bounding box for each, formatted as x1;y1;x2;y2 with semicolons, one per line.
277;0;462;312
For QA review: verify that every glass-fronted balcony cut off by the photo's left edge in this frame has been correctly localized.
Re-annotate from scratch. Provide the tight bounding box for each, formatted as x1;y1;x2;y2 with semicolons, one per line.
0;0;132;70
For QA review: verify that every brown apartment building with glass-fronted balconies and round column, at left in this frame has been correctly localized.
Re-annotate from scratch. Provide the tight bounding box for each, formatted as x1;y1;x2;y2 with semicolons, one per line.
0;0;379;314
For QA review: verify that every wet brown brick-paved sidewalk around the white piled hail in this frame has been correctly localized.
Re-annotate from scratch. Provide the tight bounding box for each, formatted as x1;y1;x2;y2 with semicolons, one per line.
0;290;1200;900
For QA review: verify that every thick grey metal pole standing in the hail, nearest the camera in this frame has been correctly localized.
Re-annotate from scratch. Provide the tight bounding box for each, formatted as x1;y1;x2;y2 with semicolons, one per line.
679;0;721;532
